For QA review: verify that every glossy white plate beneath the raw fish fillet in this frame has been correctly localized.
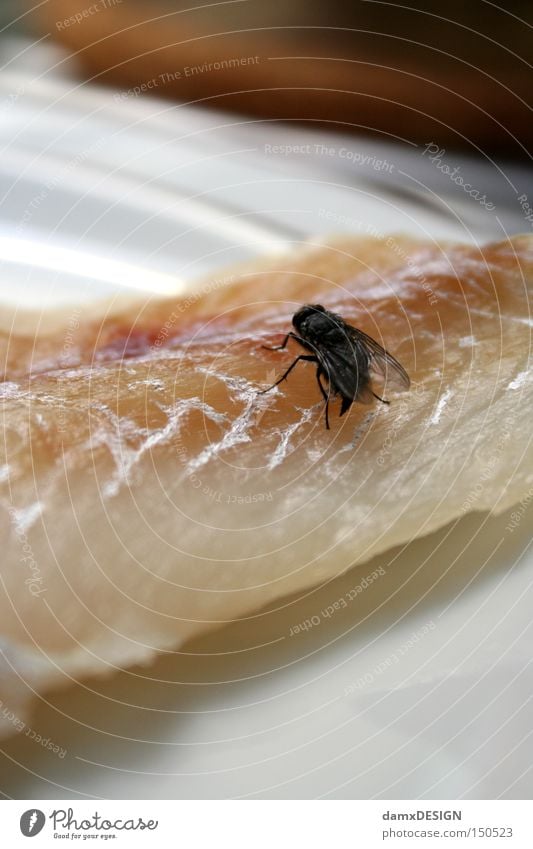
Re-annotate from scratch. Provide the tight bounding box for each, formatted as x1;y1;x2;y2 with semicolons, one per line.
0;51;533;798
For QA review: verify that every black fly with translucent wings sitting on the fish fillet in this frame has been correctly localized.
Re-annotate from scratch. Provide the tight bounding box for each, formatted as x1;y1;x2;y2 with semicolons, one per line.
260;304;410;430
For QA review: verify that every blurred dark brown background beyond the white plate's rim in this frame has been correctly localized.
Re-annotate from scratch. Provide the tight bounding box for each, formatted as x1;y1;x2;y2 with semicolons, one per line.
0;0;533;158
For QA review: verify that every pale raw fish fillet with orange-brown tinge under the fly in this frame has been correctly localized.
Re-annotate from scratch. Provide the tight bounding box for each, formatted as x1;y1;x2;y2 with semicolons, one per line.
0;236;533;733
